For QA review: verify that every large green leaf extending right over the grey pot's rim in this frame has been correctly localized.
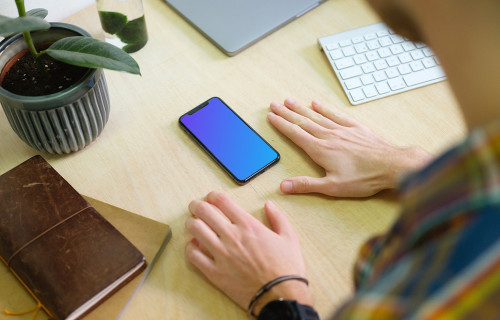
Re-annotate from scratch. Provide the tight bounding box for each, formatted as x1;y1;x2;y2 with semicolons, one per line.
46;36;141;74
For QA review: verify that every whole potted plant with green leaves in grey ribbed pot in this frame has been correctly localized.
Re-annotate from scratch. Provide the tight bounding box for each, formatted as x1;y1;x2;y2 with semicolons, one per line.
0;0;140;154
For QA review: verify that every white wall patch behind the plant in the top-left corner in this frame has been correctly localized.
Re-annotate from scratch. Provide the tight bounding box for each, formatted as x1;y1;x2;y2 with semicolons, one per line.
0;0;95;21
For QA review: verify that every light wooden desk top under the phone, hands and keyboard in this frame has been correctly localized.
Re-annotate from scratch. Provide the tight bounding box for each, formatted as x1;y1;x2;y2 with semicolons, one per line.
0;0;465;319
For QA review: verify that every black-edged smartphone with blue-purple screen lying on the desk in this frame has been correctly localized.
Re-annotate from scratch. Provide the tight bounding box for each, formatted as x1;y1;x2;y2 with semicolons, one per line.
179;97;280;184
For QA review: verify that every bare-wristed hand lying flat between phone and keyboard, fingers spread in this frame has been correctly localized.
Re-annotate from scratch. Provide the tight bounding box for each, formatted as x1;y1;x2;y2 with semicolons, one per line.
268;99;430;197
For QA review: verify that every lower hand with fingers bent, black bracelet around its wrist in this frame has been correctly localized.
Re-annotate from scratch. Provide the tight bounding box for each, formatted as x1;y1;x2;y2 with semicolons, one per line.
186;192;312;314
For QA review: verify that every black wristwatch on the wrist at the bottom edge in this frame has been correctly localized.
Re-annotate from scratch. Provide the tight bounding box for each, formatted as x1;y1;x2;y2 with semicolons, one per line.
257;299;319;320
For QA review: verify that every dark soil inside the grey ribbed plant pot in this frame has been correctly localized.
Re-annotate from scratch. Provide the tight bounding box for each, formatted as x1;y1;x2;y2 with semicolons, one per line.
1;53;88;96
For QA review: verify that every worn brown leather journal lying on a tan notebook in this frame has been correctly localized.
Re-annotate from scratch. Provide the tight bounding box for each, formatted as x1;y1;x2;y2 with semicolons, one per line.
0;156;146;319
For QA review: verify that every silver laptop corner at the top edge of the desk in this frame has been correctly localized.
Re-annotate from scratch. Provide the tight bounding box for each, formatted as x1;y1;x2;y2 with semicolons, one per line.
165;0;326;56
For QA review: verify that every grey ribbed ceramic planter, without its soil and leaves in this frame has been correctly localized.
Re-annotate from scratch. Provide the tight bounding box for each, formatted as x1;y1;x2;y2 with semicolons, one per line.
0;23;110;154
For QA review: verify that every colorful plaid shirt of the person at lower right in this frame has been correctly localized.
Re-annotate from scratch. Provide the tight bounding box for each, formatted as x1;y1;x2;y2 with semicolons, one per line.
334;122;500;320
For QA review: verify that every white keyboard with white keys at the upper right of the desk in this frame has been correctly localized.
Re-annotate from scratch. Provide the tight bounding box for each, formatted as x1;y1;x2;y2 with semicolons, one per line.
318;23;446;105
